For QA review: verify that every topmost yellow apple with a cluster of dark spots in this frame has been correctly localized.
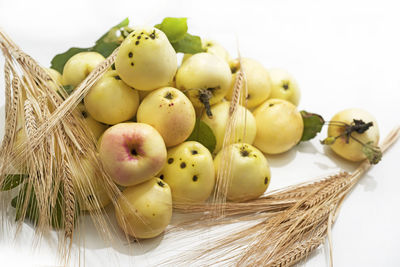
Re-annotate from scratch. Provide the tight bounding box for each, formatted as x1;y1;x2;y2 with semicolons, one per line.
115;27;178;91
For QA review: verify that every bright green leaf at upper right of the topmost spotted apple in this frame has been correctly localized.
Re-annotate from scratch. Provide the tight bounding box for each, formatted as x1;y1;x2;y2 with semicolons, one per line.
154;17;188;43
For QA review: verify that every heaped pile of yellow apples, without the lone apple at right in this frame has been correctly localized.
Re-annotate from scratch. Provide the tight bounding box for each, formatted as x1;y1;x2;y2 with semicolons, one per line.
43;27;378;241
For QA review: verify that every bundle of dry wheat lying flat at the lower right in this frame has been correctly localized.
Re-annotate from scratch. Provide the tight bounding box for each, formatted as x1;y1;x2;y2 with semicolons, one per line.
168;127;400;266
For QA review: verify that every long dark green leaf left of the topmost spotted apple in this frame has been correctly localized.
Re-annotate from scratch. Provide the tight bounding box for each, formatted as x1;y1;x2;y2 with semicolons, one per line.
51;18;129;74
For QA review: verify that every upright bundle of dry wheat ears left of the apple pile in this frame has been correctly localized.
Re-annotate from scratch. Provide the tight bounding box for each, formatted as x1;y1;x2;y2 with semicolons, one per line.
0;27;128;265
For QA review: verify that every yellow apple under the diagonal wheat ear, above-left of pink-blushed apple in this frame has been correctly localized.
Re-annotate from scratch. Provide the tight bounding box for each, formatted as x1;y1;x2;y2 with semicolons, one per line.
84;71;139;125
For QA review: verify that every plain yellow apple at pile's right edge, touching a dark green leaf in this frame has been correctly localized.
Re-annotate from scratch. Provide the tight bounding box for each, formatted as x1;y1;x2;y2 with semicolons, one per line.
253;99;304;154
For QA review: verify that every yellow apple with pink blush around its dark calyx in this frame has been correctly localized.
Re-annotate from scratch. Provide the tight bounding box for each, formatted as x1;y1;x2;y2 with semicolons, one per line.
99;122;167;186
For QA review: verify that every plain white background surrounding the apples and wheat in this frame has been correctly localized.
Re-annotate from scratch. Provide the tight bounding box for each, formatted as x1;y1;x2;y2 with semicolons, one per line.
0;0;400;266
